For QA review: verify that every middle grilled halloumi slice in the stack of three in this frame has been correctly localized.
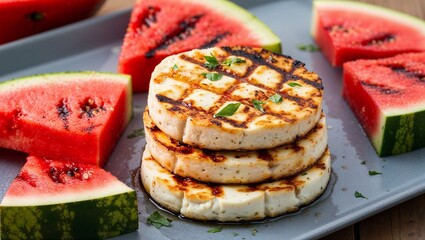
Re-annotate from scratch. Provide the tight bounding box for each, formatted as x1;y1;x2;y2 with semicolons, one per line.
143;109;327;184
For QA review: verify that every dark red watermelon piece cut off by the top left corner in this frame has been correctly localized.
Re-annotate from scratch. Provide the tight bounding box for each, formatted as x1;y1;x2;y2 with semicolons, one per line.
0;0;104;44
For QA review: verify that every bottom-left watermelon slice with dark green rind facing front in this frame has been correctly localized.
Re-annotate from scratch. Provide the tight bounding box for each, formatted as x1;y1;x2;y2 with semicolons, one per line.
0;157;138;240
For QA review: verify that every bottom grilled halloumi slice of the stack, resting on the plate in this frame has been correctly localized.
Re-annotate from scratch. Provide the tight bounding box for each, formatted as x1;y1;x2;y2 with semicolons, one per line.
141;148;331;222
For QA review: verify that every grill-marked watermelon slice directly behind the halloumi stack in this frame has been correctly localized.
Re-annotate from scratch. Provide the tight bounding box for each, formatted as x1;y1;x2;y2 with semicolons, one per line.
118;0;281;92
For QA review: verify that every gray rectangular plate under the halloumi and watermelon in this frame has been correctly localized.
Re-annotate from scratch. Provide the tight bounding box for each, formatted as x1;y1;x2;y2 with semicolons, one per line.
0;1;425;239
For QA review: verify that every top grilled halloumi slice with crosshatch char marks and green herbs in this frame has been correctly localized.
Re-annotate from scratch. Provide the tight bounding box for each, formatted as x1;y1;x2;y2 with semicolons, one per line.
148;47;323;150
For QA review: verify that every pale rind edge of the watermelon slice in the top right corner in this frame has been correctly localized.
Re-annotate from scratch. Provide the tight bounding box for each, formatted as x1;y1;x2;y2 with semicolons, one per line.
311;0;425;38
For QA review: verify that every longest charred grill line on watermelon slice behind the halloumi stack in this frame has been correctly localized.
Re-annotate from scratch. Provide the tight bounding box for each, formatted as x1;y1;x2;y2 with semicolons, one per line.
145;15;202;58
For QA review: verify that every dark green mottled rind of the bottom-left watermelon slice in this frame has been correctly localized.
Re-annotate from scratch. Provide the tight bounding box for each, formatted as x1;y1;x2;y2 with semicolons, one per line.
0;189;139;240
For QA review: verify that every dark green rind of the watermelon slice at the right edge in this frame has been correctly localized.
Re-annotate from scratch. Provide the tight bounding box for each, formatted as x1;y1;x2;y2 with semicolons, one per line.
372;110;425;157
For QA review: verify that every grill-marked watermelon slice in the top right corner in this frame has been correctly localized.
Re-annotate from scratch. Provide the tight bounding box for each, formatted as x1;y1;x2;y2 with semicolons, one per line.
311;0;425;66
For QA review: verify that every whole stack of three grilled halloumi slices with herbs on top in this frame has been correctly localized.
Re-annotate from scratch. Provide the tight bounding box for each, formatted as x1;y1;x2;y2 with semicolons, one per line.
141;47;331;222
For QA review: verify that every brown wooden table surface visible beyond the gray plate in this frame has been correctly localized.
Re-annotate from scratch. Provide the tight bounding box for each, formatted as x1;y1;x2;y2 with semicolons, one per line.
98;0;425;240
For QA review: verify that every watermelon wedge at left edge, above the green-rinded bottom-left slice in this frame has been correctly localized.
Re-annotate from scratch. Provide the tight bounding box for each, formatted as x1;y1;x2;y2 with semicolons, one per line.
0;72;132;166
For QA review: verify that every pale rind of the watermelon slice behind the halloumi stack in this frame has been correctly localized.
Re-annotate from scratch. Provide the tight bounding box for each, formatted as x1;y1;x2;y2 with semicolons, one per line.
185;0;282;53
